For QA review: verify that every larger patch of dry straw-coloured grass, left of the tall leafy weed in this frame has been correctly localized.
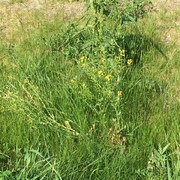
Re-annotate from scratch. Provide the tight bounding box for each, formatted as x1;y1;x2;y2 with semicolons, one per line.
0;0;84;41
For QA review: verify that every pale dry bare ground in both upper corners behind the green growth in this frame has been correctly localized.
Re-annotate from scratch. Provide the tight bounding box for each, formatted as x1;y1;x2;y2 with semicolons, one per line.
0;0;180;44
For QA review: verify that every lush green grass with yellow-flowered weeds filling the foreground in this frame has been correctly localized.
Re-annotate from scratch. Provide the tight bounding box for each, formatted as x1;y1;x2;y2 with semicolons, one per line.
0;0;180;180
